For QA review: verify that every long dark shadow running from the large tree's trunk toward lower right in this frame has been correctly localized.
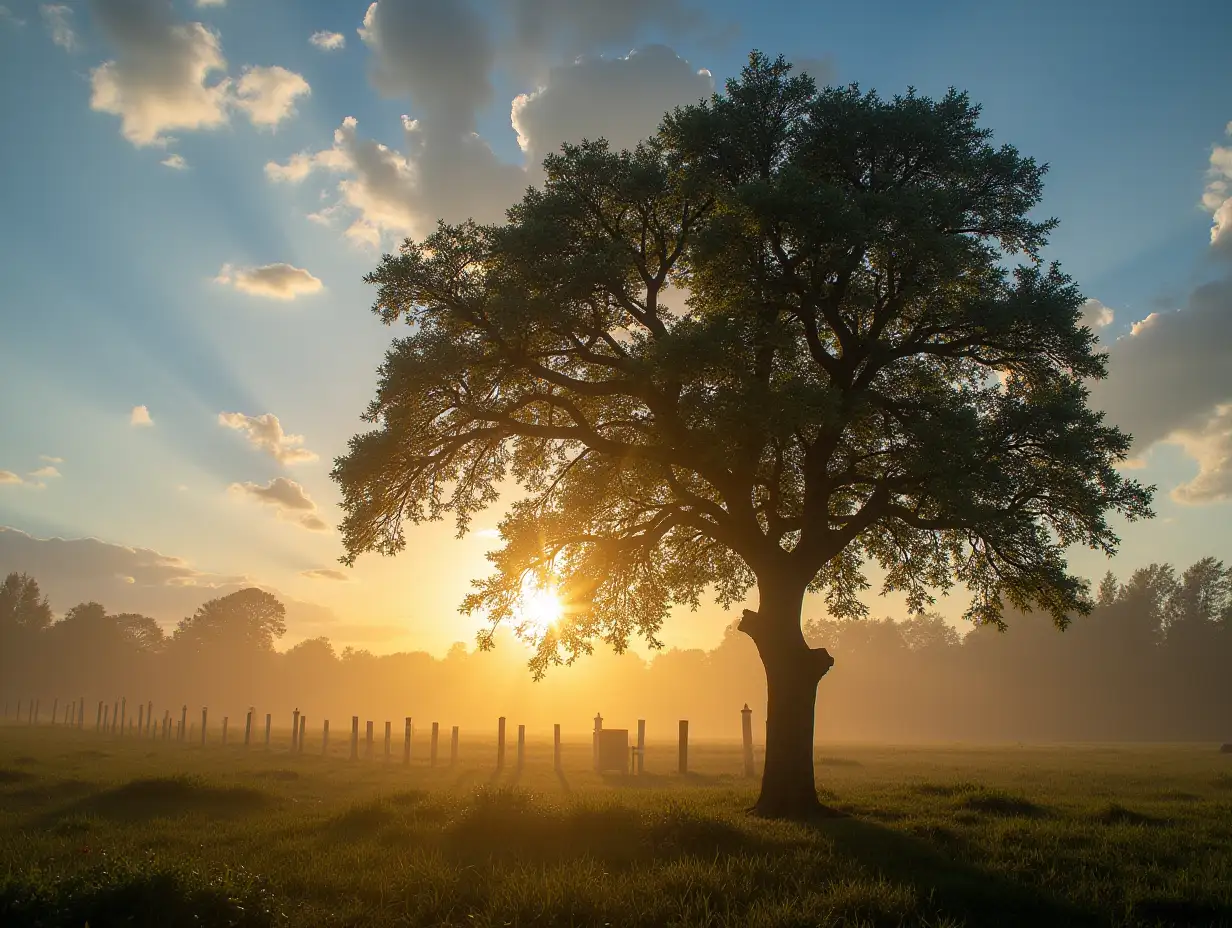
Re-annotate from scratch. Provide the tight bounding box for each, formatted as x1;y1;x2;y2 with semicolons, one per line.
813;817;1100;926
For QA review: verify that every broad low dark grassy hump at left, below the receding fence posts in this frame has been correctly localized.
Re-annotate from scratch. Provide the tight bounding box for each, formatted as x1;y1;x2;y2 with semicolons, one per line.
57;776;275;822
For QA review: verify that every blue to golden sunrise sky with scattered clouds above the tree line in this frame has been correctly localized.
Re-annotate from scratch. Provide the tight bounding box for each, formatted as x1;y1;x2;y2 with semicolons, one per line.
0;0;1232;653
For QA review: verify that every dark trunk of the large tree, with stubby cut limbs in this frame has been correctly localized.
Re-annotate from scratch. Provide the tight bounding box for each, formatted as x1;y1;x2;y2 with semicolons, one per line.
739;583;834;818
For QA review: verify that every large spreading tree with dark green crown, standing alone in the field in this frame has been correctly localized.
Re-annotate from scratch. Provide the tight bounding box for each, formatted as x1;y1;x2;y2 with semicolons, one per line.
334;53;1151;815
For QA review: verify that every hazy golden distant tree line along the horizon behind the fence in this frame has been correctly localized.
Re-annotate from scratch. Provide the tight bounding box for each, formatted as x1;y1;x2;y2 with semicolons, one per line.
0;557;1232;742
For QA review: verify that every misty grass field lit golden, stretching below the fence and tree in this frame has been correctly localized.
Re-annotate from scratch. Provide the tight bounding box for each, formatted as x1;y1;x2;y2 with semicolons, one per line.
0;726;1232;928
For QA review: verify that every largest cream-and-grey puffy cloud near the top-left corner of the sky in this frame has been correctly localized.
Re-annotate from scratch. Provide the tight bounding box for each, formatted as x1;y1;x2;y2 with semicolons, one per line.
90;0;309;145
